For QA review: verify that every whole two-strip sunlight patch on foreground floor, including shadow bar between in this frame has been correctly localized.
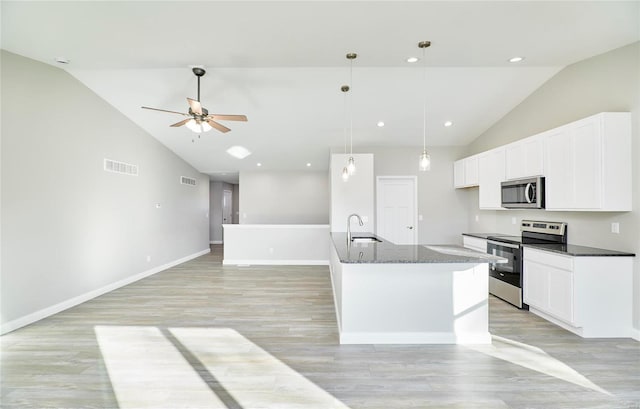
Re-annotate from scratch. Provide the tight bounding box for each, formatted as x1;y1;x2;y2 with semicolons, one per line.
94;326;349;409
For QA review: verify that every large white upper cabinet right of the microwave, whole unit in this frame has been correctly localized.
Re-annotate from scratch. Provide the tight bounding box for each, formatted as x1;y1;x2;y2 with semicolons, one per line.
544;112;632;211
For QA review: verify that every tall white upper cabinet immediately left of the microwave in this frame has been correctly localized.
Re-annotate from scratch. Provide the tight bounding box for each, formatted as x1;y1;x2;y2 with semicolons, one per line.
478;147;505;209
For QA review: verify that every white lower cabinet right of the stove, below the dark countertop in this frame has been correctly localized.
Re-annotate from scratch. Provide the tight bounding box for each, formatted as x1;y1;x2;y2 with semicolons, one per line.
523;247;633;338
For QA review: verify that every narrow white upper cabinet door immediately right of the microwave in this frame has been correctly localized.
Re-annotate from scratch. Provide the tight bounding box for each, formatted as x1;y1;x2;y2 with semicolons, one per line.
544;128;575;209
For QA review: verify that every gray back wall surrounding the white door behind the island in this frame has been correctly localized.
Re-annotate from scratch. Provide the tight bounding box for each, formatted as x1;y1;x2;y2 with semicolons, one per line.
359;146;469;244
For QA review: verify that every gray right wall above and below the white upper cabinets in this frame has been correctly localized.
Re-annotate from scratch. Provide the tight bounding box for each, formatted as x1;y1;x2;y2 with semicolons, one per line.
461;39;640;330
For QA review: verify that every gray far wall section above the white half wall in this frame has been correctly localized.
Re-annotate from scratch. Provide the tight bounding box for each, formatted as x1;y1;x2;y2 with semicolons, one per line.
239;171;329;224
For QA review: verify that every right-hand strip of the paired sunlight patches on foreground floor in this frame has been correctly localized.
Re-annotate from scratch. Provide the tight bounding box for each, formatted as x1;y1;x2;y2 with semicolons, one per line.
169;328;348;409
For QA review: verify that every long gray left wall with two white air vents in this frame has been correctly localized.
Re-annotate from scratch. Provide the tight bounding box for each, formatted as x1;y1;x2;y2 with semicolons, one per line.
0;51;209;330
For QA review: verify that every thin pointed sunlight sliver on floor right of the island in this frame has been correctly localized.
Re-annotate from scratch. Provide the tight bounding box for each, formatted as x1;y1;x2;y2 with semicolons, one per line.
466;335;613;396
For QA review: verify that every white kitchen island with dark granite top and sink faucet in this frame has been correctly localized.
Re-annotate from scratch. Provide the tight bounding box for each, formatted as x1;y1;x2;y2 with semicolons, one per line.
330;233;506;344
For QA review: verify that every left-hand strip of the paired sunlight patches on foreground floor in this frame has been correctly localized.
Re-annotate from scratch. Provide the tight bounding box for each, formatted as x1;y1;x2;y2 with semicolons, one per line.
94;326;227;409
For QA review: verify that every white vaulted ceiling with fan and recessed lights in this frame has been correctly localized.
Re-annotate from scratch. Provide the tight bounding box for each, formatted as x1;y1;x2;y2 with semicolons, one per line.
1;1;640;179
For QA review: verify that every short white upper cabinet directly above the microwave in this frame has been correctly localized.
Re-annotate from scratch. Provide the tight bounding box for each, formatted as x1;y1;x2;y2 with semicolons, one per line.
505;134;544;180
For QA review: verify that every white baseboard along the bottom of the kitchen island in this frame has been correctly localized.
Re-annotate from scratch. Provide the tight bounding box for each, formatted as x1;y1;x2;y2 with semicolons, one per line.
340;331;491;345
